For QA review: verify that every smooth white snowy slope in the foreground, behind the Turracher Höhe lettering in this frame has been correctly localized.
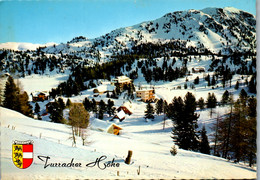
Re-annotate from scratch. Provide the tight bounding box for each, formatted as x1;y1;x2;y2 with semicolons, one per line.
0;106;256;179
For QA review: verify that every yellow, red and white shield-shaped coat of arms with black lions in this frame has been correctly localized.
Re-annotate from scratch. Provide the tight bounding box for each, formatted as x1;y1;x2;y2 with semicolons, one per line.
12;140;33;169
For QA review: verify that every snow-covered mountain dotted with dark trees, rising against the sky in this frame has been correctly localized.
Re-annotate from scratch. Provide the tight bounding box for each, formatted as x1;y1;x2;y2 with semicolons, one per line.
40;7;256;60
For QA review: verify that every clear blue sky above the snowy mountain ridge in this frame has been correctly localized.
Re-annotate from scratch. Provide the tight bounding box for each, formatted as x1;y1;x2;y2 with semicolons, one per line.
0;0;256;44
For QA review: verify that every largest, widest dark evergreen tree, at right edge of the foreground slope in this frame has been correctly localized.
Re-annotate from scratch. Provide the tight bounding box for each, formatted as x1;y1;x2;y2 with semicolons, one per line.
171;92;199;150
